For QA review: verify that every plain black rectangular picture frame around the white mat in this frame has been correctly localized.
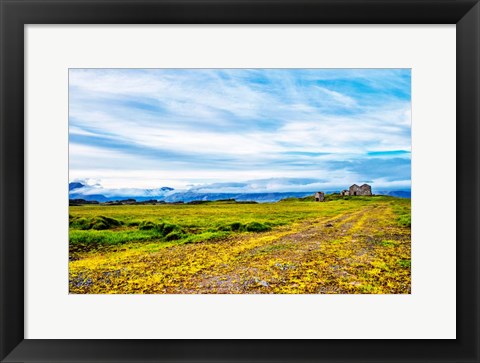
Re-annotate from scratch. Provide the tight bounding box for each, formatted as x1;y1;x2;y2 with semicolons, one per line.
0;0;480;362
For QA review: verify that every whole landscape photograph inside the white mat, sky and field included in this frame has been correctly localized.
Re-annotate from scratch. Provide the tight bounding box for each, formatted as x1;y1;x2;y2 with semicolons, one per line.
65;68;412;294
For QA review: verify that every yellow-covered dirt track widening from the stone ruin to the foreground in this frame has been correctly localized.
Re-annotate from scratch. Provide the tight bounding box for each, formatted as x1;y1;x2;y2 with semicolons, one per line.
70;205;410;294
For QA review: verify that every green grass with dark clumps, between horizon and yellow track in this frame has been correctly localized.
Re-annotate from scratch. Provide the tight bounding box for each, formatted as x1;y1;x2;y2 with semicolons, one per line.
69;196;409;249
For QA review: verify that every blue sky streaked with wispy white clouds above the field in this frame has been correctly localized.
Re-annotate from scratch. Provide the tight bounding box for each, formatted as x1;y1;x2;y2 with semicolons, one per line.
69;69;411;194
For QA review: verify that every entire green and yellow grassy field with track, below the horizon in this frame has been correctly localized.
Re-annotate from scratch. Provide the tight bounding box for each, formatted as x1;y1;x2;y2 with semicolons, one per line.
69;196;411;294
